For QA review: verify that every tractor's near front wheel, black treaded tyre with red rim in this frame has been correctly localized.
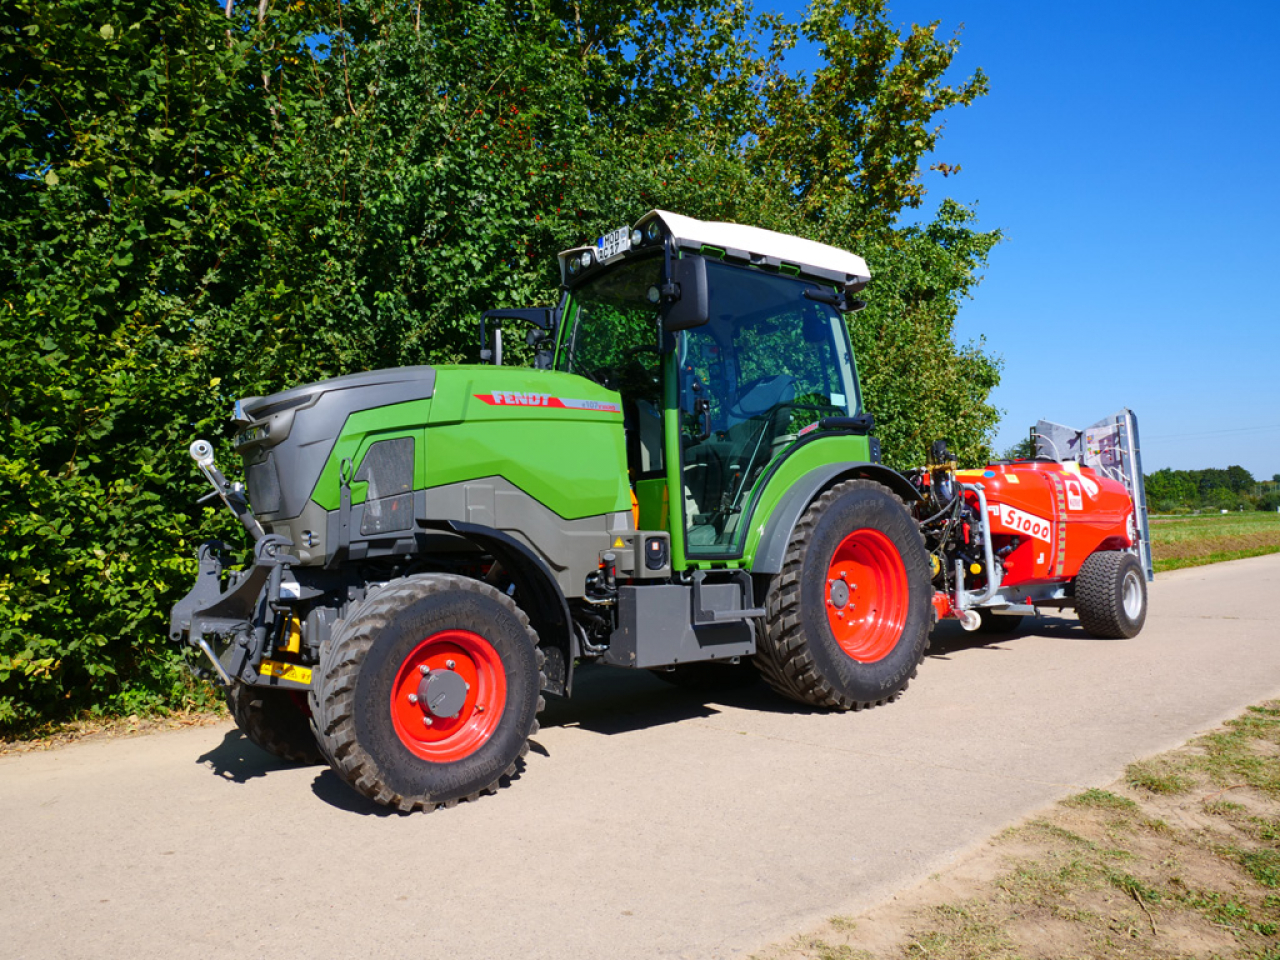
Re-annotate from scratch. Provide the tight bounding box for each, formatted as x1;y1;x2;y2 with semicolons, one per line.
311;575;543;813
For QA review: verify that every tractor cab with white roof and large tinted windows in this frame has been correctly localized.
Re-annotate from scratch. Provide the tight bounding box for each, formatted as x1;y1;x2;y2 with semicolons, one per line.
553;211;869;562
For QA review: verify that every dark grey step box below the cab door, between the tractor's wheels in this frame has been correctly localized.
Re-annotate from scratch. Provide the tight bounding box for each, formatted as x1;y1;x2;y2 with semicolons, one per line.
604;584;755;669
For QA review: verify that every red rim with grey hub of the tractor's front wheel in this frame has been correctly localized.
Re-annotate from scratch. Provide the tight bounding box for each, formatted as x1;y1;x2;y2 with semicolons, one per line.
390;630;507;763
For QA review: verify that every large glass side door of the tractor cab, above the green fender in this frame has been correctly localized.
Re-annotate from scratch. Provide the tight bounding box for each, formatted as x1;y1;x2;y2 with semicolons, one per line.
673;261;860;559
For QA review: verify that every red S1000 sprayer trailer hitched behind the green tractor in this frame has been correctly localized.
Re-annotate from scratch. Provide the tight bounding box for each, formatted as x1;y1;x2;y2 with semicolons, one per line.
910;410;1152;637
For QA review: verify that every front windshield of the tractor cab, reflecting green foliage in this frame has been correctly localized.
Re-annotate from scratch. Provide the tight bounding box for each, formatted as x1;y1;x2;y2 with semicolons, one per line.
556;257;662;389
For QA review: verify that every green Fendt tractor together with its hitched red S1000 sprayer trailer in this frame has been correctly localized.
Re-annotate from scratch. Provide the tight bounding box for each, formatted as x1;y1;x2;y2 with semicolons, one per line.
170;210;1148;812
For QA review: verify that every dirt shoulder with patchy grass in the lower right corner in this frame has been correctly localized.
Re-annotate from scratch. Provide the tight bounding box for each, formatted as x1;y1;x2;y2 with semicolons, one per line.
754;701;1280;960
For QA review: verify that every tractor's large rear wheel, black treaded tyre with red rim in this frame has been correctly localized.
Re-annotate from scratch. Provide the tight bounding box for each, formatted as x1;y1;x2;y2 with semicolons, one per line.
755;480;933;710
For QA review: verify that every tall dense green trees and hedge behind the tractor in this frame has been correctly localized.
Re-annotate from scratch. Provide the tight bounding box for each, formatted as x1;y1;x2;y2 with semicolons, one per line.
0;0;998;727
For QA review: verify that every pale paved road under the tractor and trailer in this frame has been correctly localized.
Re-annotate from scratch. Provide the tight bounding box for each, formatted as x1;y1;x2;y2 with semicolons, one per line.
0;556;1280;960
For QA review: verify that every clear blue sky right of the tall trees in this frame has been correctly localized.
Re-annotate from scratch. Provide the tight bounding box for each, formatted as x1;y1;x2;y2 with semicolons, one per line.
778;0;1280;480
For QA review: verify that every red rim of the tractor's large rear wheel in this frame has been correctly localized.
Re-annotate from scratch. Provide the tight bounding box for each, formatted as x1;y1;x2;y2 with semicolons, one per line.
823;529;910;663
